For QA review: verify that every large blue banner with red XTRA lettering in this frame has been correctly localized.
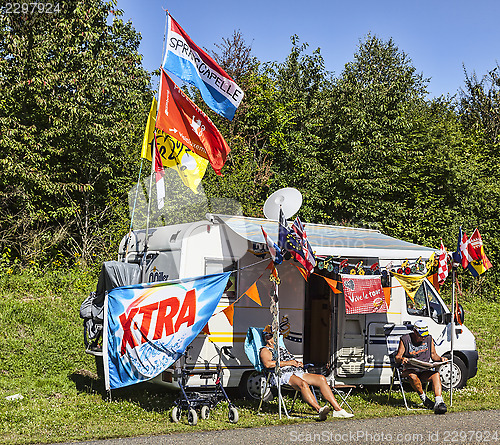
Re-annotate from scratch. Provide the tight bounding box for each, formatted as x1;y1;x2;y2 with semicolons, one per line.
103;272;231;390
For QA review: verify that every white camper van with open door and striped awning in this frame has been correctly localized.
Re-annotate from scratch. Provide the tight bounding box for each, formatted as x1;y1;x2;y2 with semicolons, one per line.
119;214;478;397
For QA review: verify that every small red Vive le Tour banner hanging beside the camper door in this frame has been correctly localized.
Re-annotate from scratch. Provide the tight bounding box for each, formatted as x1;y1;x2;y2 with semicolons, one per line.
340;274;387;314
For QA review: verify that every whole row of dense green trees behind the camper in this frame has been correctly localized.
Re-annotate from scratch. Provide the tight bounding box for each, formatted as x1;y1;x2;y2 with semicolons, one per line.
0;4;500;294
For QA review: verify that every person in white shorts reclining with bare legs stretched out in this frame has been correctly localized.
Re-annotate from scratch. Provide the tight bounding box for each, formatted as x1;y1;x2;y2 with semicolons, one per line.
260;325;354;420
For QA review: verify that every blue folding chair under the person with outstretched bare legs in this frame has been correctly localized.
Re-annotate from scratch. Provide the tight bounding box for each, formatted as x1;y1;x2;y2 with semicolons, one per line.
245;327;316;417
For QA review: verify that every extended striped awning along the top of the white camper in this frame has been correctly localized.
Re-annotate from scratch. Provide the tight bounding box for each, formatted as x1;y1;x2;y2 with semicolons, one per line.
211;215;435;259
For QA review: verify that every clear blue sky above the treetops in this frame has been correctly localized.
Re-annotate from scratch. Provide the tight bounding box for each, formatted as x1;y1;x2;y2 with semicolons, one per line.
114;0;500;97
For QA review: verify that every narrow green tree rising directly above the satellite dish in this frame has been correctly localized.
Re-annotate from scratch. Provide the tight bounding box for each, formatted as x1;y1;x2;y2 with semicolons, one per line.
270;36;332;221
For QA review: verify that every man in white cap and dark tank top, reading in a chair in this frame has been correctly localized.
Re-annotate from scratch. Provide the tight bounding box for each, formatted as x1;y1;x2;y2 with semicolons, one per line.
395;320;447;414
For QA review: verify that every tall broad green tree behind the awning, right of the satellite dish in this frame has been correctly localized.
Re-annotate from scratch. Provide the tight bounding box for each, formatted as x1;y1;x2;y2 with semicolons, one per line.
320;35;426;227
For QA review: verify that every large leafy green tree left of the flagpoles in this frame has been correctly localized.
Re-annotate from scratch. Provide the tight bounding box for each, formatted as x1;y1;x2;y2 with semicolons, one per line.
0;0;151;262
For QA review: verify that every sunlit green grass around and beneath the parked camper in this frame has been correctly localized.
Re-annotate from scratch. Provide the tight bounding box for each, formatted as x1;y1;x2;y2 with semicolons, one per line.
0;272;500;444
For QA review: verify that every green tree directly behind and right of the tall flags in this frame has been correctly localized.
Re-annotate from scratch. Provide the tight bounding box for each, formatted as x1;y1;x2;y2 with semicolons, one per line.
202;31;287;216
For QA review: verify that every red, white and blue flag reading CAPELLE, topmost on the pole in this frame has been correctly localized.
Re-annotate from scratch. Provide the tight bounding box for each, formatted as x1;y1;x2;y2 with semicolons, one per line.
162;15;244;120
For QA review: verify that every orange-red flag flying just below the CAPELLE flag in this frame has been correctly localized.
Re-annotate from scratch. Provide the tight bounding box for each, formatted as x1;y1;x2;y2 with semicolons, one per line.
156;69;231;175
